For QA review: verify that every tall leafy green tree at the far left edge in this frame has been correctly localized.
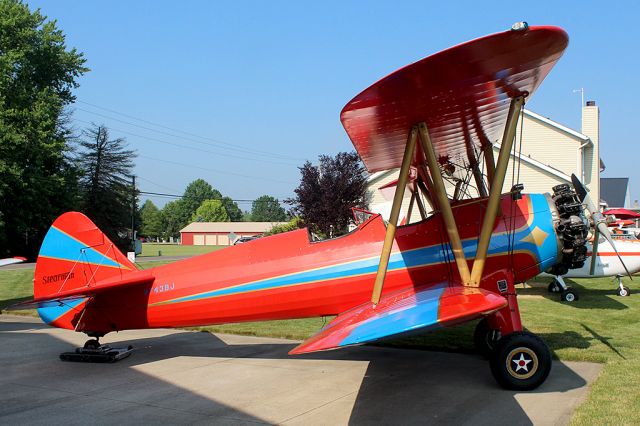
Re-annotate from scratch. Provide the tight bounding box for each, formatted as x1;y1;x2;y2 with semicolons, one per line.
0;0;88;257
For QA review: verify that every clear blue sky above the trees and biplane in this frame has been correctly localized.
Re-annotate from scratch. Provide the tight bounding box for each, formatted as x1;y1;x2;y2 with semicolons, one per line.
28;0;640;209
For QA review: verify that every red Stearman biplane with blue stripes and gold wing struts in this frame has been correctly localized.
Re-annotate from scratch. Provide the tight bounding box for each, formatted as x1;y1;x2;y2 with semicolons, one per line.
11;23;586;389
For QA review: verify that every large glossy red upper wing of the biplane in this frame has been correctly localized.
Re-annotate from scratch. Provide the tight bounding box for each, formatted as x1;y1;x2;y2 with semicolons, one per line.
340;27;569;172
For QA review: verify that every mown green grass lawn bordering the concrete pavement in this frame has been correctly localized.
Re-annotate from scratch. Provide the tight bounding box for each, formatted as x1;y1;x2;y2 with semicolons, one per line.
0;266;640;425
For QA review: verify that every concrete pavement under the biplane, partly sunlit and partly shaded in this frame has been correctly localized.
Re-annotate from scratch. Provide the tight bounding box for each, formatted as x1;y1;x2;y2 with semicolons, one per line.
0;315;602;425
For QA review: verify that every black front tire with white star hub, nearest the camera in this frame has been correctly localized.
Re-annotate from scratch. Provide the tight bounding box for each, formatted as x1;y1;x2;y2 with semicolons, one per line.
490;331;551;391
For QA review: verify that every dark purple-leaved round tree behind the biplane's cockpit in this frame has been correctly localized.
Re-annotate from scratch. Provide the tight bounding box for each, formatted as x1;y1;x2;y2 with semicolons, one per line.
286;152;367;236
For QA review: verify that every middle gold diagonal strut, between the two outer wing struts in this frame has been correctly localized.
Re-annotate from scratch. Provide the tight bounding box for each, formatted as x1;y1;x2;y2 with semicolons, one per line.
418;122;470;283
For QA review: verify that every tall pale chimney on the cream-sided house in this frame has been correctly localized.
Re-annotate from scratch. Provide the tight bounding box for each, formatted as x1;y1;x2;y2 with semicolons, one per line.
582;101;600;204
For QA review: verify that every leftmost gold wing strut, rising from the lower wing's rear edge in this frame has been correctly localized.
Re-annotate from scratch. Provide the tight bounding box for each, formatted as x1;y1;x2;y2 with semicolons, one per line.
371;126;418;305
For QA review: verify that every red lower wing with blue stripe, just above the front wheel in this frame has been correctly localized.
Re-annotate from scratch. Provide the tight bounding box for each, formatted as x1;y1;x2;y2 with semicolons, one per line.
290;284;507;354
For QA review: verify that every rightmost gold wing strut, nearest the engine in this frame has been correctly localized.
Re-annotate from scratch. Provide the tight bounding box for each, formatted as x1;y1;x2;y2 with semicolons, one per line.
469;96;524;287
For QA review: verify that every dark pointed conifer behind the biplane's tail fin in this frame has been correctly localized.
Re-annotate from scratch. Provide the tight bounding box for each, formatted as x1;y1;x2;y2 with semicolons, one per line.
78;126;135;250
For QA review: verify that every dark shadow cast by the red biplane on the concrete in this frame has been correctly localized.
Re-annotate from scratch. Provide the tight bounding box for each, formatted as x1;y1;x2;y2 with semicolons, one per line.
0;322;586;424
